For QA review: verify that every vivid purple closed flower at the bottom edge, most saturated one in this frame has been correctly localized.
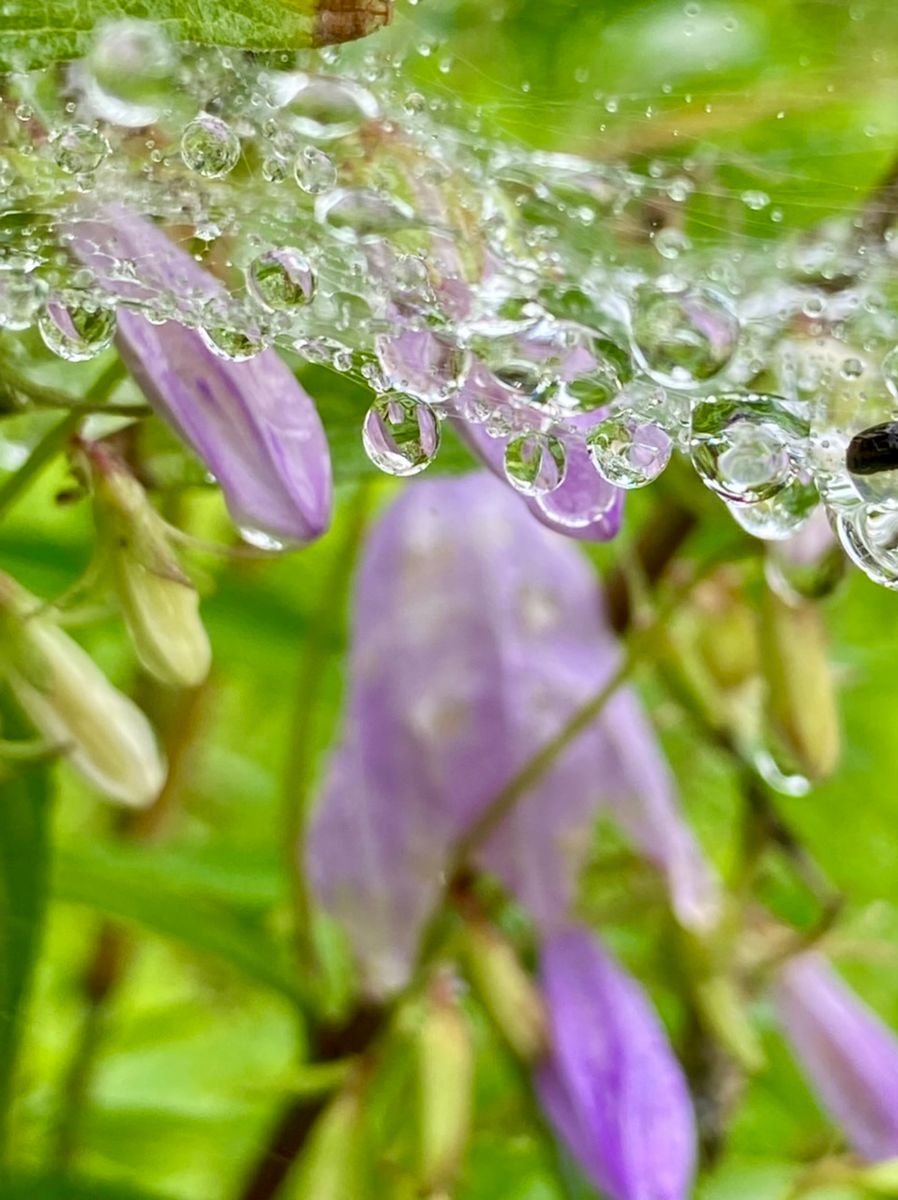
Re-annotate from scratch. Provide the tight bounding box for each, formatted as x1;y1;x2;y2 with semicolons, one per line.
535;928;695;1200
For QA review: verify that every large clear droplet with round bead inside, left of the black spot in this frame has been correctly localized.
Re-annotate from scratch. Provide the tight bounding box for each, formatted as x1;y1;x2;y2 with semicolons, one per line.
690;392;808;504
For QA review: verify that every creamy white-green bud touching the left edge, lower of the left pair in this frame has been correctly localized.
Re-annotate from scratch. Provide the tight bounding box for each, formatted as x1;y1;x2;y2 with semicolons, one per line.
0;576;166;808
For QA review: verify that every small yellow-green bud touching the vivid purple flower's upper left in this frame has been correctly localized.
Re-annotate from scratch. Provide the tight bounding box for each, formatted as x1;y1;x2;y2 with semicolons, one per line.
465;918;547;1062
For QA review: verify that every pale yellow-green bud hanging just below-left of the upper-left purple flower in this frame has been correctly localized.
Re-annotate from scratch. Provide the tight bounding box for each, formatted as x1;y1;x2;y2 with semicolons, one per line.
85;444;211;688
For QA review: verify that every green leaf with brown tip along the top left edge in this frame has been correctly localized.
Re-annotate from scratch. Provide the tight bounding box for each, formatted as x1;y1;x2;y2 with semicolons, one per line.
0;0;389;71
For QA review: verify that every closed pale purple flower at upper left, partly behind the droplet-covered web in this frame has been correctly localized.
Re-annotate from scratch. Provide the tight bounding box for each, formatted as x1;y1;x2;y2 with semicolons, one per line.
72;210;331;544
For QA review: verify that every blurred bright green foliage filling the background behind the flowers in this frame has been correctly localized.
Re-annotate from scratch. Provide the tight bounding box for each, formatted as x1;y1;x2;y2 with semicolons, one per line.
0;0;898;1200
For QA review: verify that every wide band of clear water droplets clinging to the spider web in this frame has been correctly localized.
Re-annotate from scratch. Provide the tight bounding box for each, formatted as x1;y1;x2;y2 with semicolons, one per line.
0;20;898;587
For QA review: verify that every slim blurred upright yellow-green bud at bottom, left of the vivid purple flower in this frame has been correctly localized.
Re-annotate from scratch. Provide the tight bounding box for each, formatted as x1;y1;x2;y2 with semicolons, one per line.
415;976;474;1195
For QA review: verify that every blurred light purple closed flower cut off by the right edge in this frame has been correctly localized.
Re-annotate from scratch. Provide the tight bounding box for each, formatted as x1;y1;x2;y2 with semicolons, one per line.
776;954;898;1162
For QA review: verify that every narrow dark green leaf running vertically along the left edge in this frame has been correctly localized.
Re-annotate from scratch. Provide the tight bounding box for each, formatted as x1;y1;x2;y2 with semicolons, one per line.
0;748;49;1159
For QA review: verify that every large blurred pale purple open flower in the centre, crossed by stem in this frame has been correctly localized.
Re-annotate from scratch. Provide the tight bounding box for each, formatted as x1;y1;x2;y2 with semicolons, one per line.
307;475;716;992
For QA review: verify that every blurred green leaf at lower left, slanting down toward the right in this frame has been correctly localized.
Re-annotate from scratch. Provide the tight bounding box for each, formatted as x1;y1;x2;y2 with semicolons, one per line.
52;846;300;1003
